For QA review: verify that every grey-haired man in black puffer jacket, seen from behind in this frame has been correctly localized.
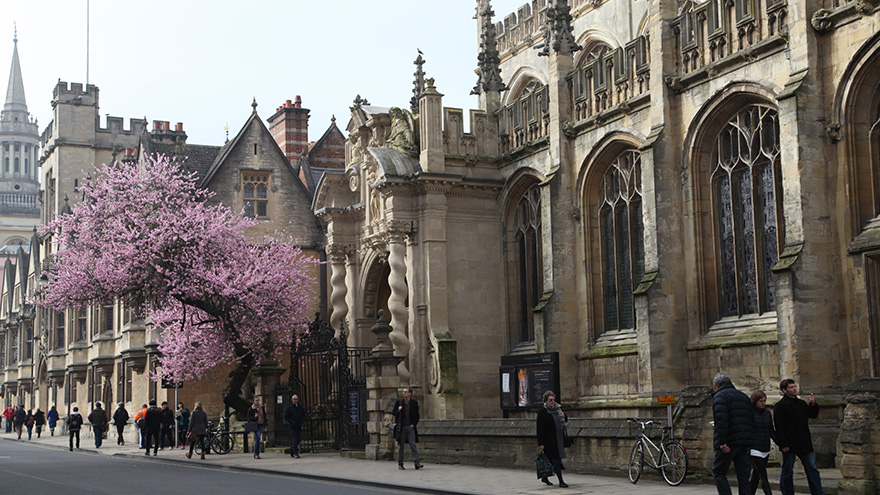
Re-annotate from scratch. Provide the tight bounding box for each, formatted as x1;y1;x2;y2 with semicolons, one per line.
712;371;755;495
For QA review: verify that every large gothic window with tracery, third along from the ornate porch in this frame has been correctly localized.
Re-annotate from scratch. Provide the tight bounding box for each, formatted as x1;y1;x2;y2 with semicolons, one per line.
711;105;782;317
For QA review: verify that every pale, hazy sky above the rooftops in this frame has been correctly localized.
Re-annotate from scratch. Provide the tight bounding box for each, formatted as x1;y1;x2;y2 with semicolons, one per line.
0;0;526;145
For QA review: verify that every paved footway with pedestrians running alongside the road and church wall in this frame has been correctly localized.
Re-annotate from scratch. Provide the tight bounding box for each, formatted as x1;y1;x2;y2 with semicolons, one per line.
0;428;840;495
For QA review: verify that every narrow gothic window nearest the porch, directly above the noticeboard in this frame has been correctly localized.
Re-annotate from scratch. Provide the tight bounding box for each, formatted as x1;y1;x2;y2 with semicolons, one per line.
513;185;543;342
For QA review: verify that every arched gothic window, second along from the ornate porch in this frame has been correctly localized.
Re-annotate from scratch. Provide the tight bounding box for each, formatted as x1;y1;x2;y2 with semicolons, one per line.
598;150;645;332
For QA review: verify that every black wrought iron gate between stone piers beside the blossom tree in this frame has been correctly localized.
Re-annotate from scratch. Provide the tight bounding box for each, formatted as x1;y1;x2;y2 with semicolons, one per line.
276;315;370;452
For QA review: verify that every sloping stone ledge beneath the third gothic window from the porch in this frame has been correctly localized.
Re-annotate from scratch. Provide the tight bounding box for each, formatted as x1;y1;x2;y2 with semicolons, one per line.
687;311;779;351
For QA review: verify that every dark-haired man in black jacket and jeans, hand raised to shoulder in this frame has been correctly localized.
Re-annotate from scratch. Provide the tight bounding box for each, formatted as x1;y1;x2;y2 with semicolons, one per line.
773;378;825;495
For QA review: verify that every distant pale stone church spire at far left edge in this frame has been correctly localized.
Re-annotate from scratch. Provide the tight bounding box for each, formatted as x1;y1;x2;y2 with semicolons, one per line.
0;34;40;250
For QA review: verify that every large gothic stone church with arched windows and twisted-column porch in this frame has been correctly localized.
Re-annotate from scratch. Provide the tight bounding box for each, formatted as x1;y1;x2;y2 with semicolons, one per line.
315;0;880;474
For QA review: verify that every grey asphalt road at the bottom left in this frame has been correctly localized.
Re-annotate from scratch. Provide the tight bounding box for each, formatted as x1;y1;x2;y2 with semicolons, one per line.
0;441;422;495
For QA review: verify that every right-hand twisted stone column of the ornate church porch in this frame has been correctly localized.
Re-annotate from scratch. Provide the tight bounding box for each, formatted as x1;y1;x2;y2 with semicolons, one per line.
388;236;410;385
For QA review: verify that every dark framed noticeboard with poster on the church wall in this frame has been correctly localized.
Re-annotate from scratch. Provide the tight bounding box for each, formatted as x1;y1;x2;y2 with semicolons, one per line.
499;352;561;411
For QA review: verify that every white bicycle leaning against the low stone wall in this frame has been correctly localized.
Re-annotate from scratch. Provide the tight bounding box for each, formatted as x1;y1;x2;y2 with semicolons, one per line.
626;418;688;486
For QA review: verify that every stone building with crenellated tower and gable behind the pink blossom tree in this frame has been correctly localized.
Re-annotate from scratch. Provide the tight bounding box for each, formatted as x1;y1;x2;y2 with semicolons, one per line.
0;82;341;434
